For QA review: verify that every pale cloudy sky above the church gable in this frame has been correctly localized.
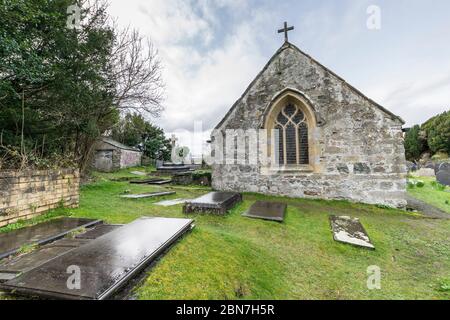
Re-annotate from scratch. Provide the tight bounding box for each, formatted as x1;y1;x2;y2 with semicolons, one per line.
110;0;450;154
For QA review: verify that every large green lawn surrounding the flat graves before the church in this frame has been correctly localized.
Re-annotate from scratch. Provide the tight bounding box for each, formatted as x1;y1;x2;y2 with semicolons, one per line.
0;168;450;299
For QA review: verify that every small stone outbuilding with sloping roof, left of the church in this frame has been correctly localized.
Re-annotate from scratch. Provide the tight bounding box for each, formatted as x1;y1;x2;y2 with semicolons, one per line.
92;137;142;172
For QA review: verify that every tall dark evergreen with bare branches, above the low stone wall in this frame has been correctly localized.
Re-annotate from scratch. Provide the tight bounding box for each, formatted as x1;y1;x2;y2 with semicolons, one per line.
0;0;163;170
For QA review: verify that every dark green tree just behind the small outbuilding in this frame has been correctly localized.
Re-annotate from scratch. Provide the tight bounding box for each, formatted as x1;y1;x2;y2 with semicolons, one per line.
112;113;172;160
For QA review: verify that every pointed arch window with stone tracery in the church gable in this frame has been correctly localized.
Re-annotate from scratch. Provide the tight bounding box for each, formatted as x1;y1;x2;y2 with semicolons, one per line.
274;103;309;166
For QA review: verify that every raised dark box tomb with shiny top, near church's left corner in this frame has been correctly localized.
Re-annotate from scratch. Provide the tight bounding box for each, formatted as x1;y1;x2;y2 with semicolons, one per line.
183;192;242;215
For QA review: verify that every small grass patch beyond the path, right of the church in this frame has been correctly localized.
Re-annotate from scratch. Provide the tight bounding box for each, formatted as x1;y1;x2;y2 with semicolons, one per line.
408;177;450;213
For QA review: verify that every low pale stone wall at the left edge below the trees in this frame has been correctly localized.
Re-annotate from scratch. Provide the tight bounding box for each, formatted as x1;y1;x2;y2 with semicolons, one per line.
0;169;80;227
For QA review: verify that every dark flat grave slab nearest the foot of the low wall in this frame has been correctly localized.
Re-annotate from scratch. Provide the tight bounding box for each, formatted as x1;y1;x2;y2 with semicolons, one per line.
0;218;101;259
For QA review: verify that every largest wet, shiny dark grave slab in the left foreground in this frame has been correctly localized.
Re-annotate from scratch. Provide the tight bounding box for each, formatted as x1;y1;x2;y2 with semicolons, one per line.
0;218;193;300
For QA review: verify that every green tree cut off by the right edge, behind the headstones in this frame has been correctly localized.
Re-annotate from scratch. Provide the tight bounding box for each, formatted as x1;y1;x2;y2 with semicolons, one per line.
422;111;450;154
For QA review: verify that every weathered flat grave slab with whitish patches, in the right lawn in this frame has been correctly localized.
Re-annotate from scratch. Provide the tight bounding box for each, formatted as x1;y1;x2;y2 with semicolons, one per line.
330;216;375;250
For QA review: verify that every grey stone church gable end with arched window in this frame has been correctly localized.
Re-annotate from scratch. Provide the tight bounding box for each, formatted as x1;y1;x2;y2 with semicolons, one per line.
213;28;407;208
